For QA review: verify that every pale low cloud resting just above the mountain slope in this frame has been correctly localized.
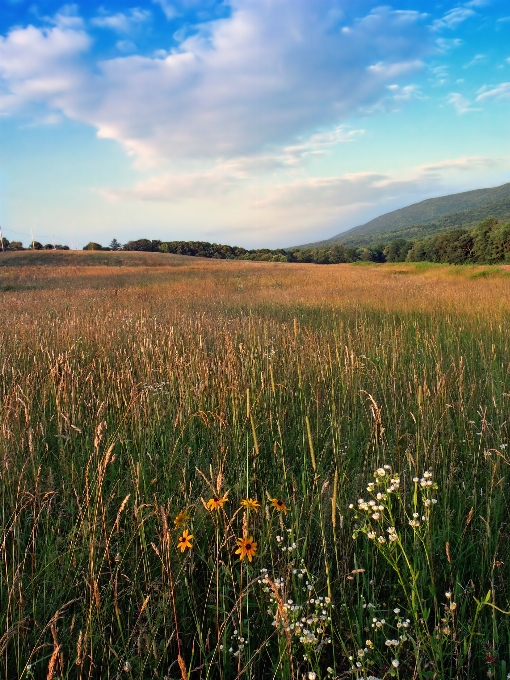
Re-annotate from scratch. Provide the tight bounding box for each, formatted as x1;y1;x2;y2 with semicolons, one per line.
228;156;510;245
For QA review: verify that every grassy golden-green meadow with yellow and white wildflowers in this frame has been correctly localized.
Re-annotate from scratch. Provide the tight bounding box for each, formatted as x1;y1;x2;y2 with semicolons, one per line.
0;252;510;680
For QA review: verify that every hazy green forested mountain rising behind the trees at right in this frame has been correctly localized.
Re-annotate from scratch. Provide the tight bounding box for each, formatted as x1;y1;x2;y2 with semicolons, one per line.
299;182;510;248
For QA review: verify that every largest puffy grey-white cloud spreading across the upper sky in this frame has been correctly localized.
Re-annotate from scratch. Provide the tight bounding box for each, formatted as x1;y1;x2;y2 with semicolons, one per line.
0;0;430;160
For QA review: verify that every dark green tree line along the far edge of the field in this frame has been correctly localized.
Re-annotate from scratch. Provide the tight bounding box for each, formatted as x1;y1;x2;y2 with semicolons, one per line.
3;218;510;264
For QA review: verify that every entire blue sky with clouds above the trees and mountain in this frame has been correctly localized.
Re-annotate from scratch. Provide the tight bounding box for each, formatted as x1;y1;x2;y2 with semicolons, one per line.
0;0;510;248
